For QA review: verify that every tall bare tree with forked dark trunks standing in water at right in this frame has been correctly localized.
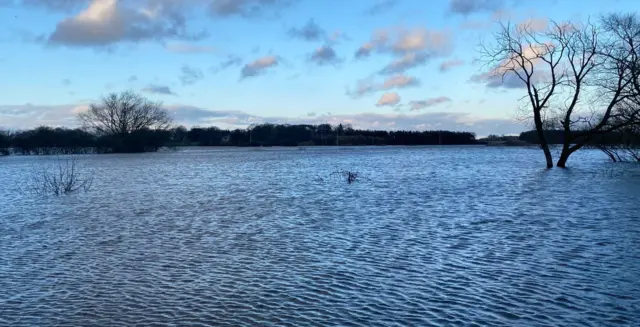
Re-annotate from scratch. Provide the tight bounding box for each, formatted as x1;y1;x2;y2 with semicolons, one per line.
481;14;640;168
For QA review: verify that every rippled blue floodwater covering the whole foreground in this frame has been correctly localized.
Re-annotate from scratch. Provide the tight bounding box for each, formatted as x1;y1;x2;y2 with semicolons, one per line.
0;147;640;326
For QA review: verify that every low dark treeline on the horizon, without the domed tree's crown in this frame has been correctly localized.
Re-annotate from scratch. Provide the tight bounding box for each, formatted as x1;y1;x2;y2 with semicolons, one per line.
0;124;477;155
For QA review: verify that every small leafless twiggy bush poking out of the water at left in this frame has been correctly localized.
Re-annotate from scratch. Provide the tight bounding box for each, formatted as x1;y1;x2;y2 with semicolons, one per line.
27;157;93;196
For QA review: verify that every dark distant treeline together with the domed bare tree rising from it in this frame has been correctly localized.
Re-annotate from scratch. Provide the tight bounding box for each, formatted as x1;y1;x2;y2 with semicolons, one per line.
0;92;477;155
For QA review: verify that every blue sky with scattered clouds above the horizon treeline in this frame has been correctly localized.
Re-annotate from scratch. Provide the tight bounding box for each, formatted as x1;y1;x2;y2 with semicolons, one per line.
0;0;640;136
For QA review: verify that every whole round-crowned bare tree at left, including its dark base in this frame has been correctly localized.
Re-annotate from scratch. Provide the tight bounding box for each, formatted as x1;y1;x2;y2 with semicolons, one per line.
78;91;173;152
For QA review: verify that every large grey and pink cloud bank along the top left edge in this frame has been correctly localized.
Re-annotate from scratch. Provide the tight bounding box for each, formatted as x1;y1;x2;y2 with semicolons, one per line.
37;0;295;48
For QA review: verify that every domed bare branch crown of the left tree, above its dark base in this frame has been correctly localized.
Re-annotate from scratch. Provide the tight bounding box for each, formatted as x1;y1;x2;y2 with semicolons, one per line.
78;91;172;136
